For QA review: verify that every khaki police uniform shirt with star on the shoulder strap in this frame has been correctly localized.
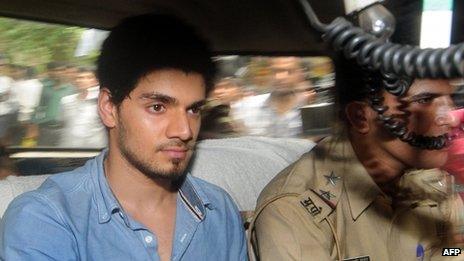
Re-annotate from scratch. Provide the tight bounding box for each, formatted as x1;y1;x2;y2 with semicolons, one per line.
250;139;464;261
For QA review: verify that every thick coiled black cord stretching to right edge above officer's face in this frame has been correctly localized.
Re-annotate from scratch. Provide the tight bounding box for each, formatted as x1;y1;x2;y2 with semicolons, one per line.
323;17;464;82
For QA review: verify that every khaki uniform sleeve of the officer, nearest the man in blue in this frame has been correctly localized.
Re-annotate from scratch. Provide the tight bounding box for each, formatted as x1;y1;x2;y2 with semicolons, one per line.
255;198;333;261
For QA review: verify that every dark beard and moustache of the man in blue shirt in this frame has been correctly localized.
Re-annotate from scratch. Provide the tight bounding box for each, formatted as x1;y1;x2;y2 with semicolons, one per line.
118;120;193;183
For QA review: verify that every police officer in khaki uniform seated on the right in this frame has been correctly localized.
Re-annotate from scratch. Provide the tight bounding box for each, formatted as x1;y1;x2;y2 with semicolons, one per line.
251;56;464;260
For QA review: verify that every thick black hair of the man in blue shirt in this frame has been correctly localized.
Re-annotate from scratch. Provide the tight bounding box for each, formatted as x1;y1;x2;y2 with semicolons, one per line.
97;14;215;105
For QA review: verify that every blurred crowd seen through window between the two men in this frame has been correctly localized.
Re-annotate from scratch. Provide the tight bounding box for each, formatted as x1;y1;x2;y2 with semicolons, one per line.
200;57;334;139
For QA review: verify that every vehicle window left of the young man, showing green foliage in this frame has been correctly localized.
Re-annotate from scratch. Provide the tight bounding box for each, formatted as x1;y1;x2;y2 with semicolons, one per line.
0;18;106;148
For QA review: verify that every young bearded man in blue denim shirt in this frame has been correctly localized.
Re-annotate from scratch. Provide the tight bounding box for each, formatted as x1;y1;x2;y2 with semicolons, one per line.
0;15;246;260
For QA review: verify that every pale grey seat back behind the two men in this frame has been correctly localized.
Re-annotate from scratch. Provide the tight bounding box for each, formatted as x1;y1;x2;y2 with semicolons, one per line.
0;137;315;217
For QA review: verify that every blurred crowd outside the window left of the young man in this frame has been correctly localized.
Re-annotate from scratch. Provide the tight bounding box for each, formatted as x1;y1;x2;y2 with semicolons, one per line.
0;56;106;148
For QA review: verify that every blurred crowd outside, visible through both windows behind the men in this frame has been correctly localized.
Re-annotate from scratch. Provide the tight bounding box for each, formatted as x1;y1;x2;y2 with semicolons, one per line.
0;56;333;148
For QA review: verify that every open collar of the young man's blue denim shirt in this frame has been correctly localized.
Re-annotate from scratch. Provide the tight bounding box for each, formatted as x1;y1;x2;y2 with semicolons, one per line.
91;149;214;223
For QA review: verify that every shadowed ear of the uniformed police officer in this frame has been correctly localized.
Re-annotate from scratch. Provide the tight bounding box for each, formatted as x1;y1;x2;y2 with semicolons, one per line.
345;101;370;134
